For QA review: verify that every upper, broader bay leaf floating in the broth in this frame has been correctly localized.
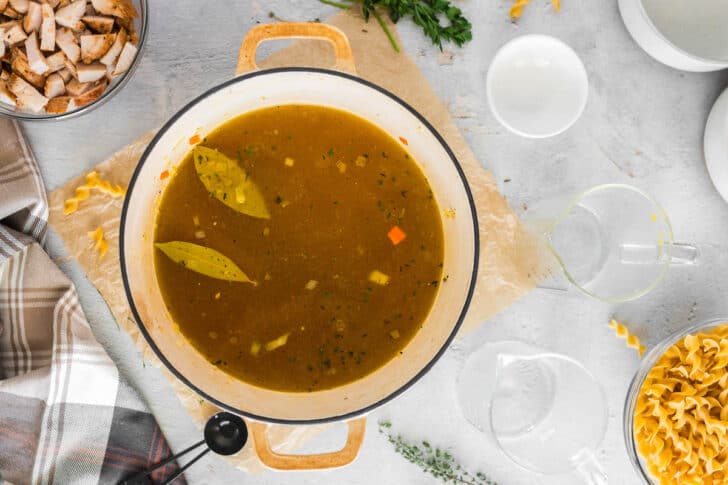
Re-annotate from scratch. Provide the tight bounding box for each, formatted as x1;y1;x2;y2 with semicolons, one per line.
192;145;270;219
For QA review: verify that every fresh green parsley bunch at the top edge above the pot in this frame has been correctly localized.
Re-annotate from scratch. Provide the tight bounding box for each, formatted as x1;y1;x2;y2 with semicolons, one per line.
319;0;473;52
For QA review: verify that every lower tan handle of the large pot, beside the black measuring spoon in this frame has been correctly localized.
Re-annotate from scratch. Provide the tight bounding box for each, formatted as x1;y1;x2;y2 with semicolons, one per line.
248;417;367;470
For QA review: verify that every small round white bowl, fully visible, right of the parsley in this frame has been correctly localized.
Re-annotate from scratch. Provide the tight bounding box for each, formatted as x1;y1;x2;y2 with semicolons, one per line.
486;35;589;138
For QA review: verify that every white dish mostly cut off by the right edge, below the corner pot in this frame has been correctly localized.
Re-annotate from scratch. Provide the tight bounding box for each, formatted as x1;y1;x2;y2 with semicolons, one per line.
704;89;728;202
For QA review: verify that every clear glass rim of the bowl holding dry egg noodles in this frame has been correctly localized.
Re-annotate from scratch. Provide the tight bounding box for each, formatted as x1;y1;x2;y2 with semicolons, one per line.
623;317;728;485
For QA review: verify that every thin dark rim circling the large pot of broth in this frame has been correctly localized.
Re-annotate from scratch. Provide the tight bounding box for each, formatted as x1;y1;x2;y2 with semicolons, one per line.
119;67;480;425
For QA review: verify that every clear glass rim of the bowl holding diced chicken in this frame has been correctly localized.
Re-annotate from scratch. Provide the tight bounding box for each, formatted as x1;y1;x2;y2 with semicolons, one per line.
0;0;149;121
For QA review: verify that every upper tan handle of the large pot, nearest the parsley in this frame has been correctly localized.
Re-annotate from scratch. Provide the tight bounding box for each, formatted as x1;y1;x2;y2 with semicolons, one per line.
236;22;356;75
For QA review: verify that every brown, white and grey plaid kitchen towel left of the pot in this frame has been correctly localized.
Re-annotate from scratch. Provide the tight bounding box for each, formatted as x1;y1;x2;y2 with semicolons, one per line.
0;119;185;485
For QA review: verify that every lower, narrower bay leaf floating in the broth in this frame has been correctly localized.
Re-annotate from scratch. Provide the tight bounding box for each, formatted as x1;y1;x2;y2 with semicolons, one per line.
154;241;257;285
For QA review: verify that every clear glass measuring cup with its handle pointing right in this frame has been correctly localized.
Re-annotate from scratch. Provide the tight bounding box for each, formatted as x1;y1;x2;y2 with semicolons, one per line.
527;184;698;302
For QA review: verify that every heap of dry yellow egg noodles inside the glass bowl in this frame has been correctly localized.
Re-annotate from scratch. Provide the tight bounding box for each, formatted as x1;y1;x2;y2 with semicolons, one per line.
634;324;728;485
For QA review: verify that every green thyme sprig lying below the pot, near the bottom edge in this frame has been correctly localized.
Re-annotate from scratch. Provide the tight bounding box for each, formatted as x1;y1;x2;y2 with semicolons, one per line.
379;421;498;485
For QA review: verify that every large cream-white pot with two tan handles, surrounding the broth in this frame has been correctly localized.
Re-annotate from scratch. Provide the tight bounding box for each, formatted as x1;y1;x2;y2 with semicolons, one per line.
120;24;478;469
